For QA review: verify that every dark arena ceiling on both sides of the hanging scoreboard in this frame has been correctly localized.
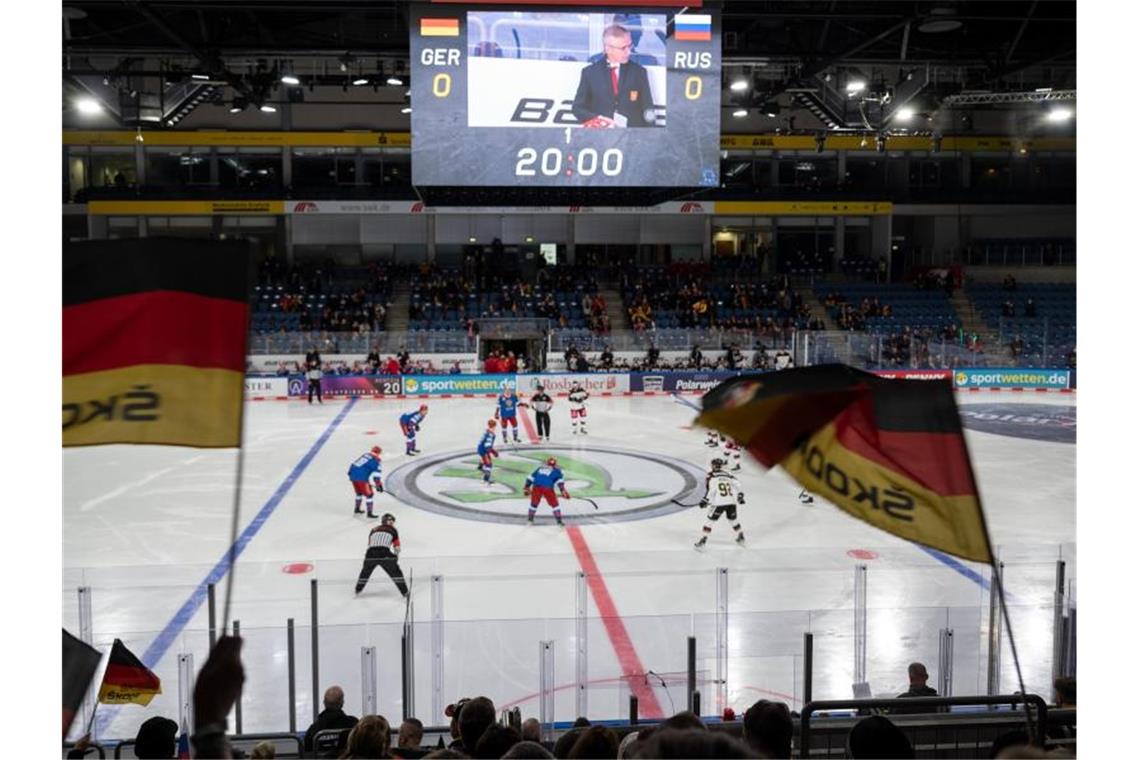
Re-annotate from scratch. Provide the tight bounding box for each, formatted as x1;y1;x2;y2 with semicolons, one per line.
63;0;1076;129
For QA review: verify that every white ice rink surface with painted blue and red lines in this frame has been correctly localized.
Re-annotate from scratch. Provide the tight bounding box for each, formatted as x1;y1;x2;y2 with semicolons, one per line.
63;392;1076;737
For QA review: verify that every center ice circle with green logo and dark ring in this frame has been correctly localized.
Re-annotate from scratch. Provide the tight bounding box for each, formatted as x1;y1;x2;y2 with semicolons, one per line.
385;444;705;524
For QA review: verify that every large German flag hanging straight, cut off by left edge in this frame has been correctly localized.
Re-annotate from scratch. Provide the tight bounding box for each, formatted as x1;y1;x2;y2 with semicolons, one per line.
63;238;250;447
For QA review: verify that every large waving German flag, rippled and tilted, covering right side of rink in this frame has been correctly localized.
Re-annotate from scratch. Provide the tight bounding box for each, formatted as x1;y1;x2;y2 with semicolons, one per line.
697;365;993;563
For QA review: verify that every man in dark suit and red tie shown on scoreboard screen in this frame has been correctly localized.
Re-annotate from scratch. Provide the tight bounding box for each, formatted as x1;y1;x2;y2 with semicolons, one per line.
573;24;654;128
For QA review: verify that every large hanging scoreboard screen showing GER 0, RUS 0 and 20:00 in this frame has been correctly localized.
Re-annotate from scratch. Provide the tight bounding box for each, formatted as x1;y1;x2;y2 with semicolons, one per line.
410;5;720;187
